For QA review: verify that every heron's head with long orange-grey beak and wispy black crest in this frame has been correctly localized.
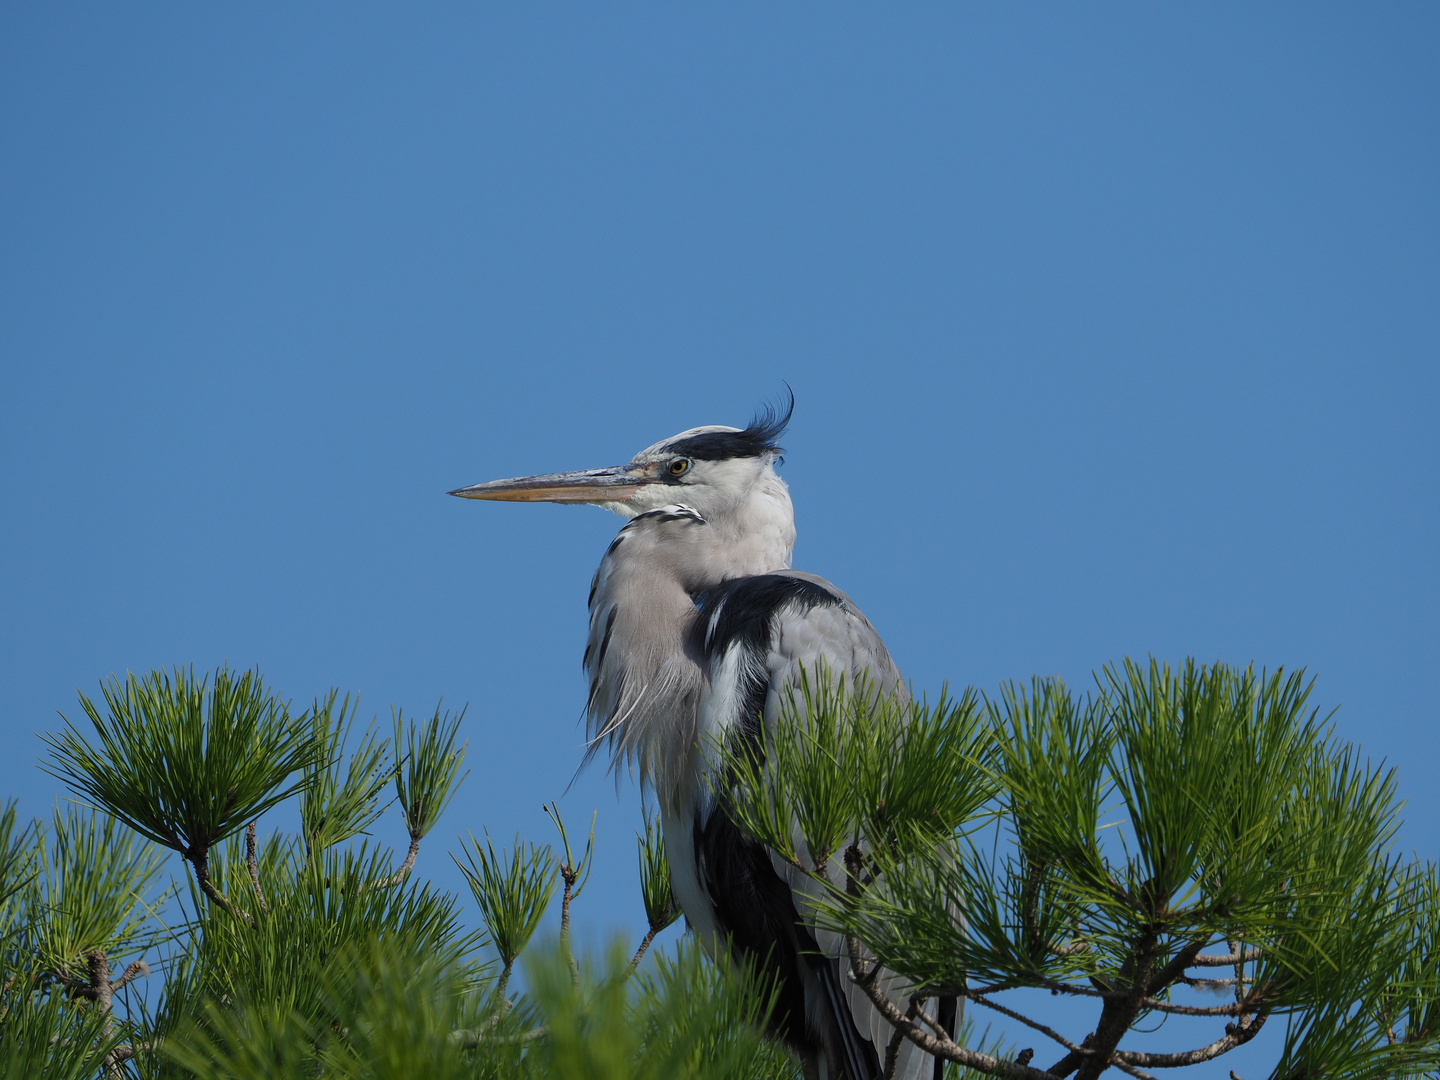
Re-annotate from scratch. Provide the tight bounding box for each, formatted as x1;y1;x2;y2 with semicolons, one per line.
449;393;795;518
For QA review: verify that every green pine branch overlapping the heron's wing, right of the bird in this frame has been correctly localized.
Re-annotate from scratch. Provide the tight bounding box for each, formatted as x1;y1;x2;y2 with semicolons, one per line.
714;661;1440;1080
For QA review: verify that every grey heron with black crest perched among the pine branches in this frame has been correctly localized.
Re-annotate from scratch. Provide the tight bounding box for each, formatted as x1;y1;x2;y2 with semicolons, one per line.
449;395;956;1080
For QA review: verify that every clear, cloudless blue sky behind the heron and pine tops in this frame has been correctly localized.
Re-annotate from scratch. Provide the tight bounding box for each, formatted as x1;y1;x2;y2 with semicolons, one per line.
0;3;1440;1077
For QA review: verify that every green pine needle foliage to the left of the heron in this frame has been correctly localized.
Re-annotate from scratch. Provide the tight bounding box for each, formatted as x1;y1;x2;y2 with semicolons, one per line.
0;668;796;1080
